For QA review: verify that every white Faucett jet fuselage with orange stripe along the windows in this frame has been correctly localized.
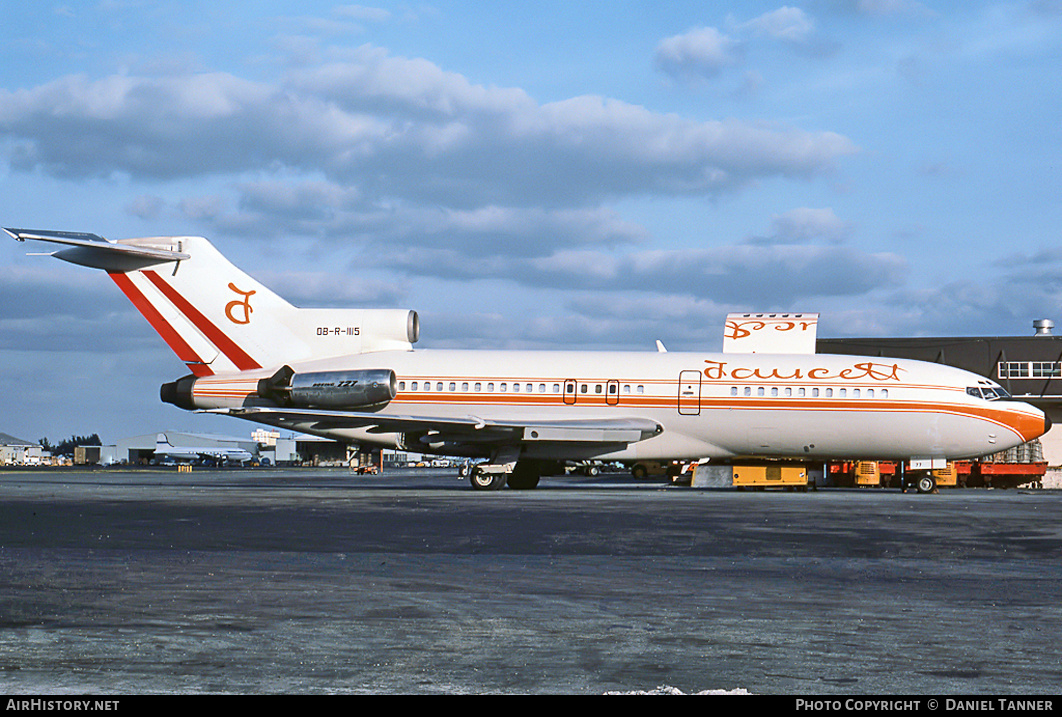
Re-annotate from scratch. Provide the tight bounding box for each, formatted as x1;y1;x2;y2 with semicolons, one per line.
184;351;1045;460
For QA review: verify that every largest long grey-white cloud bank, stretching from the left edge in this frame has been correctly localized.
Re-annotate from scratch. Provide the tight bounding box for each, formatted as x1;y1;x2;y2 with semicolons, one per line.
0;48;856;207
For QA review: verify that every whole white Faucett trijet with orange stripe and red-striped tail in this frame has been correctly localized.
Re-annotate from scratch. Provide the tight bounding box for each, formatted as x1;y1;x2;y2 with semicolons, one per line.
5;229;1050;490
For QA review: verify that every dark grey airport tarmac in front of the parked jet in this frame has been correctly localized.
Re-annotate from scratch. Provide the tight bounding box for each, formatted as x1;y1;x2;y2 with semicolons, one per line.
0;468;1062;696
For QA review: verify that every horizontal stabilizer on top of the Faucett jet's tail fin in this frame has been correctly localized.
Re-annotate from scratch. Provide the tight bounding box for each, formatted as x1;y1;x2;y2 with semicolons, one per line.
4;228;189;273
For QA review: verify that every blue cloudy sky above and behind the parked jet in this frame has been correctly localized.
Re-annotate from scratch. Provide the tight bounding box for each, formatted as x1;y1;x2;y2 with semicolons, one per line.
0;0;1062;442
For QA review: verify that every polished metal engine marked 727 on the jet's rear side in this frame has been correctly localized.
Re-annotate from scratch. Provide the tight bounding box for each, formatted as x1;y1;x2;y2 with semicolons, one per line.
258;365;397;410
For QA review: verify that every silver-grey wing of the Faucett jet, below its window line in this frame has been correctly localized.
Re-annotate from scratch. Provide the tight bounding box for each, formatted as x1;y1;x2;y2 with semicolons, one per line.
209;407;664;445
